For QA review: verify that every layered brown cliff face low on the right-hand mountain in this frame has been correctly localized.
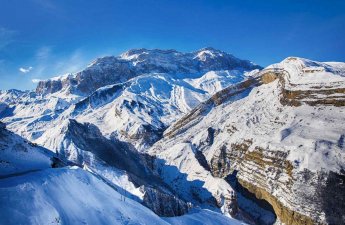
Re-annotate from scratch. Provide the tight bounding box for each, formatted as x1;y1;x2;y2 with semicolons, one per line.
210;140;322;224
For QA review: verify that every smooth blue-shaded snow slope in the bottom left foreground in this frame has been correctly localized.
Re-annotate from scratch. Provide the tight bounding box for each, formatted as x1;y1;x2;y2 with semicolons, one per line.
0;167;239;225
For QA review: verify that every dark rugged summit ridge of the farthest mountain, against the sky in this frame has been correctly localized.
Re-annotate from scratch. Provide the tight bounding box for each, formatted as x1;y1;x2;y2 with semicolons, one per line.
36;48;261;95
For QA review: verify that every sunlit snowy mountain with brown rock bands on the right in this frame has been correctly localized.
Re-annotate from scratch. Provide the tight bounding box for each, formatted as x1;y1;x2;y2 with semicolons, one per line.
149;58;345;225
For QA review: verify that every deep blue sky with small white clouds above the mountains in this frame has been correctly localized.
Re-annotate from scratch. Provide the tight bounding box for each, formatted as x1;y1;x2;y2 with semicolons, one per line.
0;0;345;89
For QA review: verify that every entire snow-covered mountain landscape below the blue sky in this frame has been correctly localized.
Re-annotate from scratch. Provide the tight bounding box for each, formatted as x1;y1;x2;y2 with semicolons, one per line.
0;48;345;225
